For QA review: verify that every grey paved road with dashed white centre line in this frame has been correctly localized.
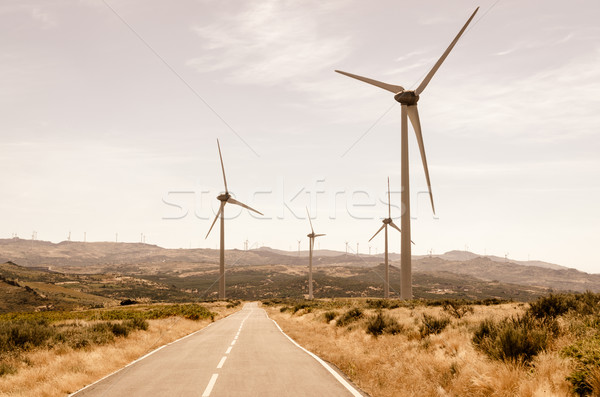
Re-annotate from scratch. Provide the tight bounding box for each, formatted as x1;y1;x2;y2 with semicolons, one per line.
73;303;362;397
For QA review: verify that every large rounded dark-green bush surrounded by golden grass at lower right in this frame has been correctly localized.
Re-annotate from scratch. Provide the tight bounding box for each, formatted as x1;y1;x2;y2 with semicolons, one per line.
473;315;553;363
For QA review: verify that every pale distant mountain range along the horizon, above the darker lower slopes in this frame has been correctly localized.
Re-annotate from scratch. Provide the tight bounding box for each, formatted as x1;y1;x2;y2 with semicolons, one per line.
0;239;600;292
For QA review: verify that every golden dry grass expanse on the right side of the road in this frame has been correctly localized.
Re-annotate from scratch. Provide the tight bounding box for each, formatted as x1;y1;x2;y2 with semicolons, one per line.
267;303;571;397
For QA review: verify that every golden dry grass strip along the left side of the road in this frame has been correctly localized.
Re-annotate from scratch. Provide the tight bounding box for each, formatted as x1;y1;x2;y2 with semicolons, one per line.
0;303;241;397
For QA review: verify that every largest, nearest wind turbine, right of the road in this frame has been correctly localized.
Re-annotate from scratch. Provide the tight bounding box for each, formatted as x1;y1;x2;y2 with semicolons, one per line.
336;7;479;299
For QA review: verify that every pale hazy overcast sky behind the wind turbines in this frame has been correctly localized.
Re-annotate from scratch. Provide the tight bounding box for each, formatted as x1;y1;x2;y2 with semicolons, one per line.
0;0;600;273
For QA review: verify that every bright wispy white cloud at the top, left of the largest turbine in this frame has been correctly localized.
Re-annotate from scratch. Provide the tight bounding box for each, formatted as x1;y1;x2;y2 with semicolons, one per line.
187;1;350;89
